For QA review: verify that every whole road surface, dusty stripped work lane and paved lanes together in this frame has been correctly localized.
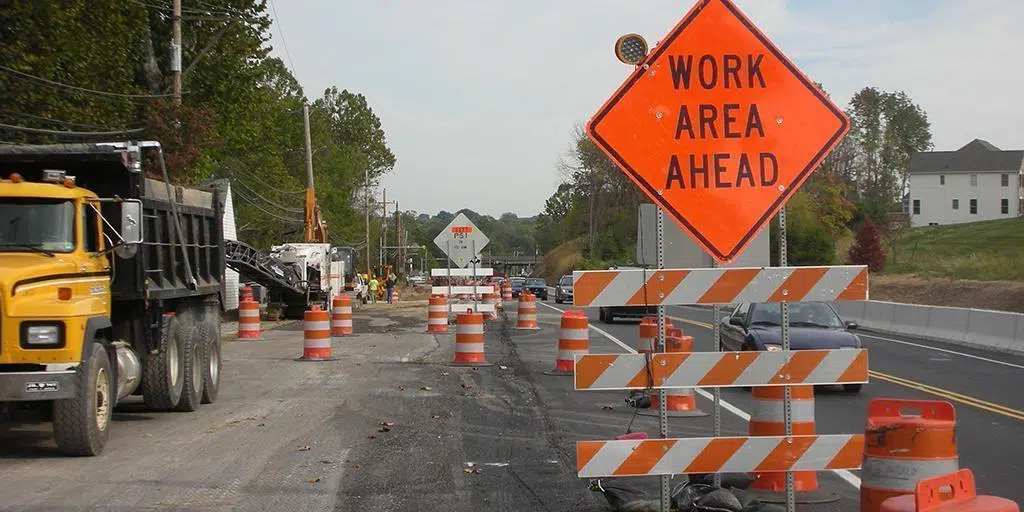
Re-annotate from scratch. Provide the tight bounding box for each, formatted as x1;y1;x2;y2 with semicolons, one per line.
0;304;1024;512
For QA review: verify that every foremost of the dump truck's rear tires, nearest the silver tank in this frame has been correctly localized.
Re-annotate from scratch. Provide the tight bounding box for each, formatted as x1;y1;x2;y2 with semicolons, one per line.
142;316;185;411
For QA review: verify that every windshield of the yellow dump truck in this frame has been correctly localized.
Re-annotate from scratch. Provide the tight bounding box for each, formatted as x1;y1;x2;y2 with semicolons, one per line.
0;198;75;253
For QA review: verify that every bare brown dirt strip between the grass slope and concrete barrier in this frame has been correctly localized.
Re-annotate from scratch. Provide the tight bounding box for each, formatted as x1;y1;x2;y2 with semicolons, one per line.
870;274;1024;313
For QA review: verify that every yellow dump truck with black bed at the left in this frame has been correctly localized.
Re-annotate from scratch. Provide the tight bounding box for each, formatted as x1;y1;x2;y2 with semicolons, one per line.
0;142;225;456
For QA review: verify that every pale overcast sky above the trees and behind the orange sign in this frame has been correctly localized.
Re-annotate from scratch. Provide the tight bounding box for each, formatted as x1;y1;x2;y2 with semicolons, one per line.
271;0;1024;216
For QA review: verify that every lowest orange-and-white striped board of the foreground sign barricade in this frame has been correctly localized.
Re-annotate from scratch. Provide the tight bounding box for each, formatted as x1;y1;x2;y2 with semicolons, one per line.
577;434;864;478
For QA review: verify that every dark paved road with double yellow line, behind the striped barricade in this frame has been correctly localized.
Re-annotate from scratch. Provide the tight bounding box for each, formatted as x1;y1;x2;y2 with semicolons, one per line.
551;304;1024;502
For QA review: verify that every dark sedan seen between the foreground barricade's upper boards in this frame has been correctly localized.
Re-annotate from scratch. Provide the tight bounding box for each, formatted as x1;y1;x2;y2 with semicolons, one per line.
718;302;861;392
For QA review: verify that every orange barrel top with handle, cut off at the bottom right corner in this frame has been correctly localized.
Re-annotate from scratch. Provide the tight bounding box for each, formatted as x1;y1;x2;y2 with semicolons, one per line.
882;469;1021;512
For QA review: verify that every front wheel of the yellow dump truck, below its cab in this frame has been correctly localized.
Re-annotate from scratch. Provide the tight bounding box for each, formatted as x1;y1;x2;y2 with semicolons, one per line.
53;343;114;457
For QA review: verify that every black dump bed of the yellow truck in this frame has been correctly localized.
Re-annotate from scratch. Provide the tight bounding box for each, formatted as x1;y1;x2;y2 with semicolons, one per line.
0;143;225;300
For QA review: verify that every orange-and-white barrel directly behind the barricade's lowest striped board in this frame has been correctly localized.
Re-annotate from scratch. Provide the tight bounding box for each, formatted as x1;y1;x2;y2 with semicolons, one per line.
749;385;839;504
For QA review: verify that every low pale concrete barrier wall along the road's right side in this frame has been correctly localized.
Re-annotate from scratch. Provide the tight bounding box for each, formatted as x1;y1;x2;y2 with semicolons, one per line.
834;300;1024;354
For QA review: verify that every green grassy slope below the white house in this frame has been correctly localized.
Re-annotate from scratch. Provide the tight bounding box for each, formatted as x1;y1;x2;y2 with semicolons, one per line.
884;217;1024;281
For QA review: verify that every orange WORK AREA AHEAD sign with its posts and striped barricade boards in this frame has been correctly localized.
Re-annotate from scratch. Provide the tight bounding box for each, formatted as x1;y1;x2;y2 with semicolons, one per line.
573;0;867;512
